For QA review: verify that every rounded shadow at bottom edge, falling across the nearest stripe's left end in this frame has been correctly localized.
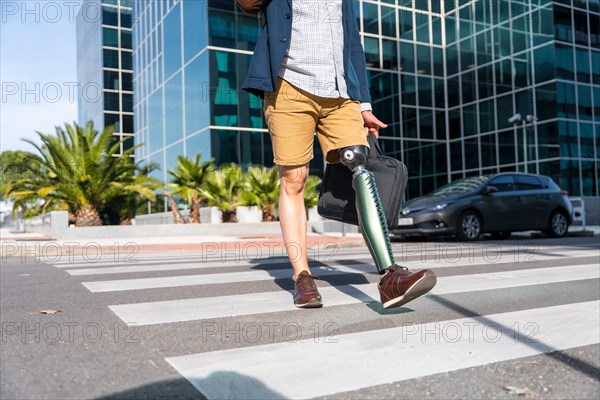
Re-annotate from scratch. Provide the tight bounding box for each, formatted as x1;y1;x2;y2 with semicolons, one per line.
95;371;287;400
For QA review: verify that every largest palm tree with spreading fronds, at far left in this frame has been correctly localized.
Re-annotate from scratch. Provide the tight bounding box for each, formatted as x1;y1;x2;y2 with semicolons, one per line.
6;122;157;226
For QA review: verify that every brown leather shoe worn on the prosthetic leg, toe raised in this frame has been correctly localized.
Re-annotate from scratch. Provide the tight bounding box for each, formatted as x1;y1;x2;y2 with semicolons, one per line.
377;264;437;308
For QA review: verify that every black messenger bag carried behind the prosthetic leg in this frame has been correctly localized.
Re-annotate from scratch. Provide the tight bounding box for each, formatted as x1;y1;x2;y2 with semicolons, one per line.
317;133;408;229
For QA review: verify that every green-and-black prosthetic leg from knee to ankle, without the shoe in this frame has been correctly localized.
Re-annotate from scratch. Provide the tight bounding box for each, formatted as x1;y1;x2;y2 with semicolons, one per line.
338;145;394;273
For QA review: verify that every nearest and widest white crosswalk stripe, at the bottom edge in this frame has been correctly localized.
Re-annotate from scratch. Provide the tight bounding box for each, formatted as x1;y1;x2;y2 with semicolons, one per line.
167;301;600;399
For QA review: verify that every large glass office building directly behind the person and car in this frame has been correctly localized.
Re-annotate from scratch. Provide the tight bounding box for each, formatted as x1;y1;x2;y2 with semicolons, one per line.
133;0;600;197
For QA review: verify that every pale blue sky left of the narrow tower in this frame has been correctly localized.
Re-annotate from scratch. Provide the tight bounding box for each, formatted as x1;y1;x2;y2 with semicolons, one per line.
0;0;81;151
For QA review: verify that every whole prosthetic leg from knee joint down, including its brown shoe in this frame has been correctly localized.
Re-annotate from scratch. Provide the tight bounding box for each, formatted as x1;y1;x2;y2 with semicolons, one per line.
338;145;437;308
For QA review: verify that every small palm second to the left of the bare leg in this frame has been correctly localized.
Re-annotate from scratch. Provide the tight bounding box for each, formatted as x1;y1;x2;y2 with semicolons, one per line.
201;164;245;222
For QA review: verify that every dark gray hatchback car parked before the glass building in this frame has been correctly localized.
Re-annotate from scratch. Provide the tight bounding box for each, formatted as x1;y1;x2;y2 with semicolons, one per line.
393;173;573;241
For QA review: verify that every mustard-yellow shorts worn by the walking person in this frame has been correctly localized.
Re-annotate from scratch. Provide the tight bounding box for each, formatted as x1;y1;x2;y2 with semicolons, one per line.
264;78;368;165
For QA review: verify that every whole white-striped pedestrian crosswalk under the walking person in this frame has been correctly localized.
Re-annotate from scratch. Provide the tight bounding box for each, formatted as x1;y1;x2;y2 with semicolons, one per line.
49;244;600;399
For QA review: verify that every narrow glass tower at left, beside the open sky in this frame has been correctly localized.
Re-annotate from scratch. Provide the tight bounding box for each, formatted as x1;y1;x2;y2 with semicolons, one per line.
77;0;134;155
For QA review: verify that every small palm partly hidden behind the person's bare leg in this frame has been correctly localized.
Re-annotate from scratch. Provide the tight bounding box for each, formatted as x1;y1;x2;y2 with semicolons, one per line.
240;166;280;221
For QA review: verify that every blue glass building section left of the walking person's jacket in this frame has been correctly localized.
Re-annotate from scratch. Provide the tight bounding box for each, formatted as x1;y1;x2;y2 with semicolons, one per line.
133;0;273;181
